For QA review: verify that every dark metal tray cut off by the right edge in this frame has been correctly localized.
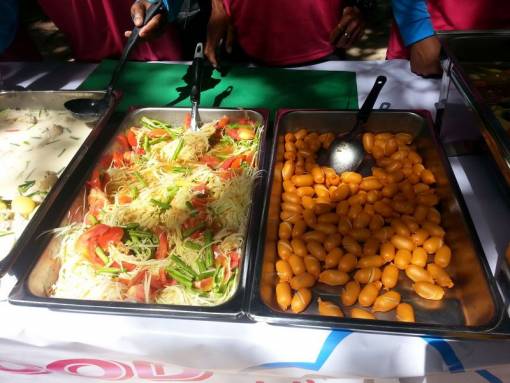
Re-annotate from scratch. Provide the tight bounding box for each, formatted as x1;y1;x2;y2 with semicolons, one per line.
438;31;510;185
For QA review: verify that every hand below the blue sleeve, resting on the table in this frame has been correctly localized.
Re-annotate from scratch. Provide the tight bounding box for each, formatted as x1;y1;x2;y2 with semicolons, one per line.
409;36;443;76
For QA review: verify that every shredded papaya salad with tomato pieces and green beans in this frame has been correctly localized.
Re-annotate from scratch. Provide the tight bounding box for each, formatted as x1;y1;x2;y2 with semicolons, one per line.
51;116;262;306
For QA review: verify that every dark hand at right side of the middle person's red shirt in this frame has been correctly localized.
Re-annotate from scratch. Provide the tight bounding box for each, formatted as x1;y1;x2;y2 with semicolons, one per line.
329;7;365;49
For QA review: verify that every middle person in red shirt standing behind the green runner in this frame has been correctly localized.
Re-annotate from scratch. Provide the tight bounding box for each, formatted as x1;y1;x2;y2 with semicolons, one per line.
132;0;372;66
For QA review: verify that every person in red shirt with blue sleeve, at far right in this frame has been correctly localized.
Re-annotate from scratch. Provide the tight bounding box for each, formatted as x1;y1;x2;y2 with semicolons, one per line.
387;0;510;76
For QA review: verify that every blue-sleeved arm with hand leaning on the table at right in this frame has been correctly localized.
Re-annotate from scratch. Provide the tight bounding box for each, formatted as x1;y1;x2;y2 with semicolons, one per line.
392;0;442;76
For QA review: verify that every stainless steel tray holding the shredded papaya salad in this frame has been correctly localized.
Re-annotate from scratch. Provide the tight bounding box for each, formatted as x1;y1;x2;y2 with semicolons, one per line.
9;108;268;320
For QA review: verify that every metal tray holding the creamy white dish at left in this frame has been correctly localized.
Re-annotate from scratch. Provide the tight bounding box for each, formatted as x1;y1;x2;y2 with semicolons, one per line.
0;91;119;277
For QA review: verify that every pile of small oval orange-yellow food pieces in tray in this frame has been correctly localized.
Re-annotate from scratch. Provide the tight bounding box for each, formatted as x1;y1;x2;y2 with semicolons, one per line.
273;129;453;322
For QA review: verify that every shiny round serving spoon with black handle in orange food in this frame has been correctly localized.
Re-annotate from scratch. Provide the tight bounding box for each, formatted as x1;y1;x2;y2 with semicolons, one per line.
322;76;386;173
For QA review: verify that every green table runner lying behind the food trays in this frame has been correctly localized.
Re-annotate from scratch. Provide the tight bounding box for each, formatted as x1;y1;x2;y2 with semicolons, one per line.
81;60;358;111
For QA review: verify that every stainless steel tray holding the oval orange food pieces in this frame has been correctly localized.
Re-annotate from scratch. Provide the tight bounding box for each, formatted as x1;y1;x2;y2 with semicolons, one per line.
249;110;510;337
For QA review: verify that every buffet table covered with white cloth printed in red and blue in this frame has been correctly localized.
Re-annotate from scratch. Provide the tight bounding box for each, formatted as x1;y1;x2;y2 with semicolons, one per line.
0;60;510;383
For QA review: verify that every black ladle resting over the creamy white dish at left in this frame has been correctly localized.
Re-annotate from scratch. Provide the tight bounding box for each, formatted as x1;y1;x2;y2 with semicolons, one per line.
64;0;163;121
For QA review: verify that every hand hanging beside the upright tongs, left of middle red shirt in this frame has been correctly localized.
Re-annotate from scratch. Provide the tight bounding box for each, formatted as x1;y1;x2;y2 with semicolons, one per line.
204;0;234;68
